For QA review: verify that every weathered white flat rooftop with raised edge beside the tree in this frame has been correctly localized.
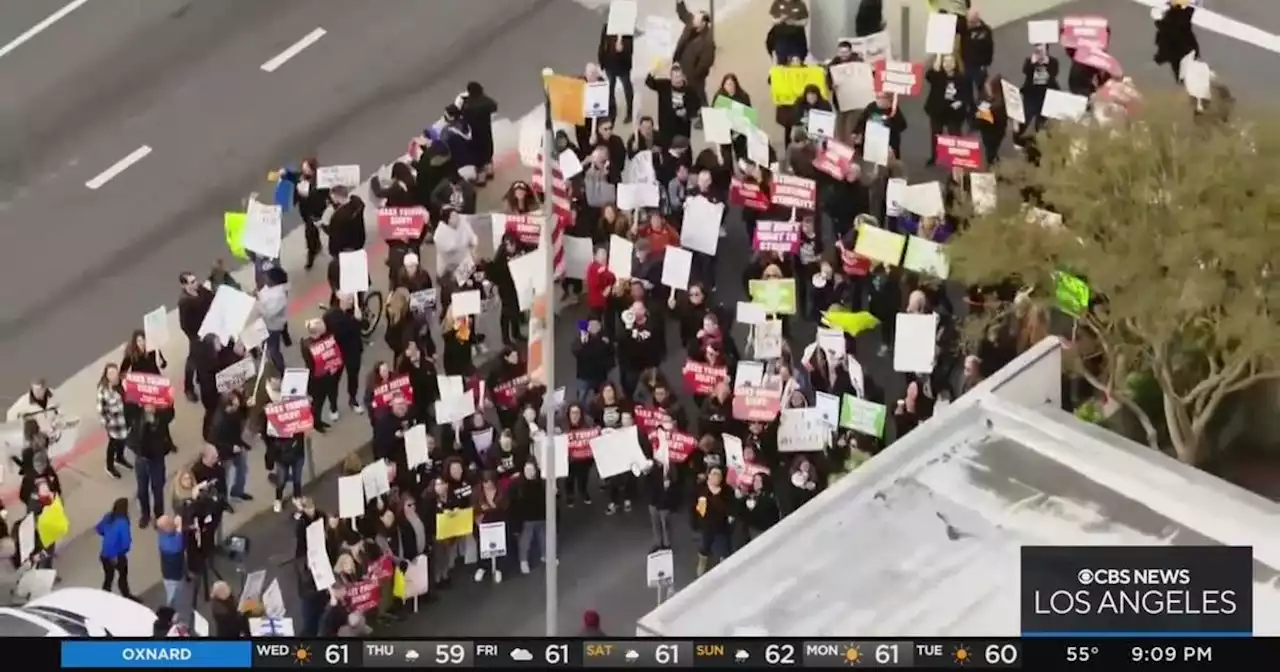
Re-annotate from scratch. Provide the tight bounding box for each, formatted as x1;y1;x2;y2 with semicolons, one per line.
637;338;1280;637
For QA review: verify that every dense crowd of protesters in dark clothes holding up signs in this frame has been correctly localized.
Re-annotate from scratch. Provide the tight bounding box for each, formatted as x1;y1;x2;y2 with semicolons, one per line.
0;0;1198;636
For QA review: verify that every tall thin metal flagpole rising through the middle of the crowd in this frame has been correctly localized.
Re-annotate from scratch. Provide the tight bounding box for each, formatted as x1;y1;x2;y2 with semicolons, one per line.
538;68;559;637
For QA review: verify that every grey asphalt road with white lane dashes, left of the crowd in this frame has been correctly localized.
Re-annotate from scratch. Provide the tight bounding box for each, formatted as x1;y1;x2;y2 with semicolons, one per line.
0;0;600;394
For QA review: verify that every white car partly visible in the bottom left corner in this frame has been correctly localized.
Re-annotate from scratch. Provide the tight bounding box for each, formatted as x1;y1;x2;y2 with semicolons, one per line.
0;588;209;639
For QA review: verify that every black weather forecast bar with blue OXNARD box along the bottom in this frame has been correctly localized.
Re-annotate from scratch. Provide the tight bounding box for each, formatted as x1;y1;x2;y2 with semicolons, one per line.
47;636;1280;671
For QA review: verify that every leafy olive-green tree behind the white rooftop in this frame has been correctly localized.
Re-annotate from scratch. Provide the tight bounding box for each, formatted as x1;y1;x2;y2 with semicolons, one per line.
948;90;1280;465
